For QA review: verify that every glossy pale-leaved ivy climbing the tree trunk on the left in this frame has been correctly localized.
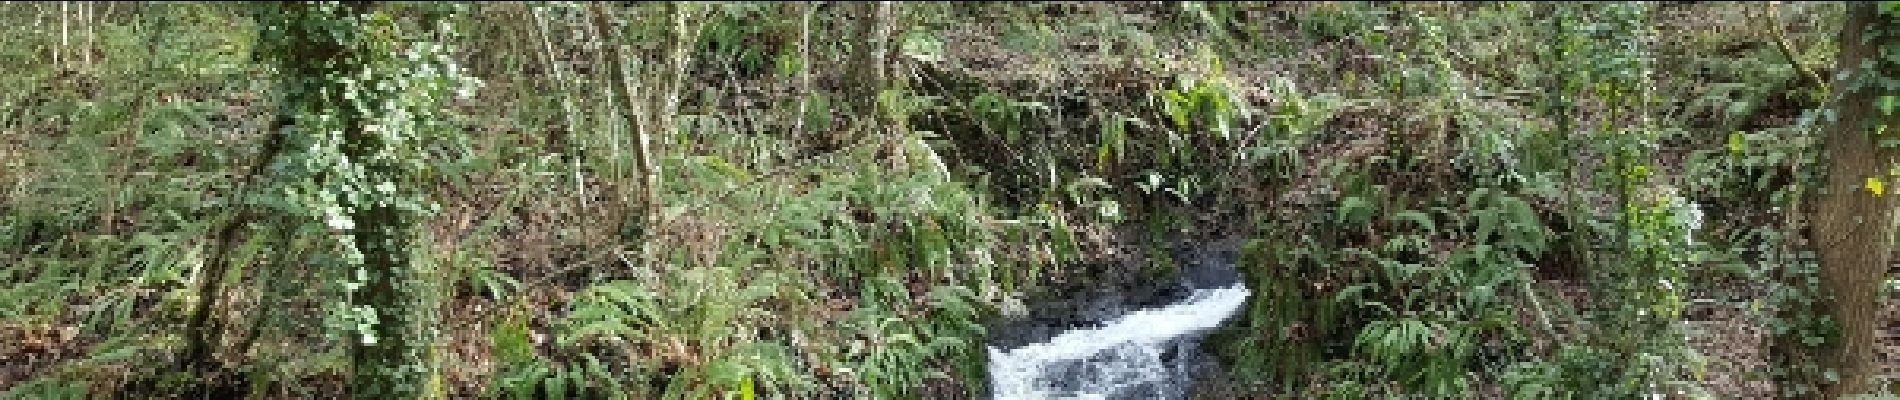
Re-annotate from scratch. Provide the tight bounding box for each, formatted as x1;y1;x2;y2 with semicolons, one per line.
257;2;475;398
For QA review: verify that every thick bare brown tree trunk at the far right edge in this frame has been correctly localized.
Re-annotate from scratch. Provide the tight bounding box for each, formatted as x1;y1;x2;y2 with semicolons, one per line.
1815;2;1900;398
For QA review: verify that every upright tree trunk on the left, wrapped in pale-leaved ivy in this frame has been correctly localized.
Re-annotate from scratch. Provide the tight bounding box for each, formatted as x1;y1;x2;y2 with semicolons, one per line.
262;2;435;398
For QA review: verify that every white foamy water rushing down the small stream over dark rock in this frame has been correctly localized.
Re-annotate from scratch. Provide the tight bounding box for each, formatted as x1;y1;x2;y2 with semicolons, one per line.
990;284;1250;400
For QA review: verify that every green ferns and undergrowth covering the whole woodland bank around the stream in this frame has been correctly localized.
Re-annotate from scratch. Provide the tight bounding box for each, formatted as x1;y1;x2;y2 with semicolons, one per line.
0;2;1896;398
